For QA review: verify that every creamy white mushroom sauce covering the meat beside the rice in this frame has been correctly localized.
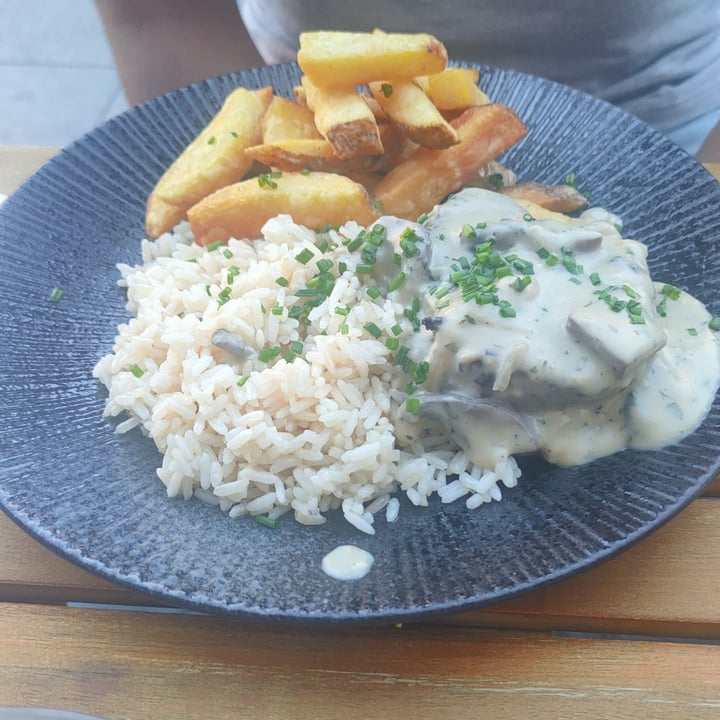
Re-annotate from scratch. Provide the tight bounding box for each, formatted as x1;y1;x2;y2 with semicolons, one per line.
383;189;720;467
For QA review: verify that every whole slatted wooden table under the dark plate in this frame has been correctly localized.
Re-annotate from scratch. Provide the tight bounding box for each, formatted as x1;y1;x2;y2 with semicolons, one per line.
0;148;720;720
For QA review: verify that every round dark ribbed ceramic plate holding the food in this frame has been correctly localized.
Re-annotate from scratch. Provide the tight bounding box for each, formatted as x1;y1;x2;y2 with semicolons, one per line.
0;66;720;622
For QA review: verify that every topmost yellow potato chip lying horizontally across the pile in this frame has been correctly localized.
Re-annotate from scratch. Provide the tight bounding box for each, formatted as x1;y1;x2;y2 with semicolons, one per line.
297;31;447;87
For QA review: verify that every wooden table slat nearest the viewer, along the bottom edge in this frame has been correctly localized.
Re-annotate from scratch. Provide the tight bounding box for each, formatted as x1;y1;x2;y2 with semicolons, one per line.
0;605;720;720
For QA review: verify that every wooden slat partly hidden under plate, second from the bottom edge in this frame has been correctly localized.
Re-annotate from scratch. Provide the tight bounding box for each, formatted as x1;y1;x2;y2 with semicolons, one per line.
0;499;720;638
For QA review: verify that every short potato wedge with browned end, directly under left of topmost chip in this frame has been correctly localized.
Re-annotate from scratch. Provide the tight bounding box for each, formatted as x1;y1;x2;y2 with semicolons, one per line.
302;76;383;158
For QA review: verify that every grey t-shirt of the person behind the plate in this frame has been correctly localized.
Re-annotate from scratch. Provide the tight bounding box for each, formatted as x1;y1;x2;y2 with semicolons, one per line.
241;0;720;130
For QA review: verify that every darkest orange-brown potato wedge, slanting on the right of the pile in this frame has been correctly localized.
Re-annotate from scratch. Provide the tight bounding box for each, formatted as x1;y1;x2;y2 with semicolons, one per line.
375;104;527;220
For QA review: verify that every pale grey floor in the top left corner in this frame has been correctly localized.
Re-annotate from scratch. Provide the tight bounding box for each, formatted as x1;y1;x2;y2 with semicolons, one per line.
0;0;128;146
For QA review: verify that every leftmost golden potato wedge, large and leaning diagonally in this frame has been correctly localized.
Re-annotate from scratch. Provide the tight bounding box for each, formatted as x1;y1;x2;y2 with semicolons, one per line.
145;87;273;237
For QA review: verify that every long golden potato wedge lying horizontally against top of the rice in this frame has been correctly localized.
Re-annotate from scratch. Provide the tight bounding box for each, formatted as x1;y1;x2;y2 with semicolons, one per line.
188;173;379;245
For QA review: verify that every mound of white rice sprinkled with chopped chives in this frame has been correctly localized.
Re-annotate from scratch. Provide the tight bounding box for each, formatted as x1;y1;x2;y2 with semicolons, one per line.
94;216;520;534
